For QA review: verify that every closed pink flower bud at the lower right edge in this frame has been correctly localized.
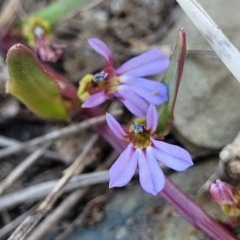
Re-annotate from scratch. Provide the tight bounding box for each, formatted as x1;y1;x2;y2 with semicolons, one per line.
209;179;240;217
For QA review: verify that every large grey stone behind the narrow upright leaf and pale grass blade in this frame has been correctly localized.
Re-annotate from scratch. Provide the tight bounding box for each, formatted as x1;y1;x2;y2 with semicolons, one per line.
161;0;240;149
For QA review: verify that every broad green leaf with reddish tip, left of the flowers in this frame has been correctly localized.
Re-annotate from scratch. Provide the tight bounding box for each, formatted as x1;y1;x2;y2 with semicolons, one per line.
6;44;69;119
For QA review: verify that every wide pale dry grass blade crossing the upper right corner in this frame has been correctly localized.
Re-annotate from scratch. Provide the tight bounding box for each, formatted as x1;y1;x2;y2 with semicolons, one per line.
177;0;240;82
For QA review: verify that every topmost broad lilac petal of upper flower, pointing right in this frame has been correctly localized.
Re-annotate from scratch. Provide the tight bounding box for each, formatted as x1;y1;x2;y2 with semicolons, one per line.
117;50;170;77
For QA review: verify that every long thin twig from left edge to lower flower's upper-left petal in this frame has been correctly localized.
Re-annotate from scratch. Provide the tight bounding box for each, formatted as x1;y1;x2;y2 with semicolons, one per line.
0;110;122;158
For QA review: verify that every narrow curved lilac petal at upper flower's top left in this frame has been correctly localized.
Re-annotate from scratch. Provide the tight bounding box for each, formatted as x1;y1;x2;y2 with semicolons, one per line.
88;38;113;65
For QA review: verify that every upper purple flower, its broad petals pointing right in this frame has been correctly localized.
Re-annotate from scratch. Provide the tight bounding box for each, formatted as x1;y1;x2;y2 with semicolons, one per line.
79;38;169;117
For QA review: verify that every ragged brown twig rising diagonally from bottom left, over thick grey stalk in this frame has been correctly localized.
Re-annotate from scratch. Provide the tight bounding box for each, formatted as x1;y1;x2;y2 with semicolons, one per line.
9;135;98;240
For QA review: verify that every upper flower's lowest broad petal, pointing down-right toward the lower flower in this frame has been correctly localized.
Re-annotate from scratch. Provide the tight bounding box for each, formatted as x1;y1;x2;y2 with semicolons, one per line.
114;85;149;117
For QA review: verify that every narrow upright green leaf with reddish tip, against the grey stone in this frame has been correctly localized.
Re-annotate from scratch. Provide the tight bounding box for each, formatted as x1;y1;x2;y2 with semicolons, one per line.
157;28;186;136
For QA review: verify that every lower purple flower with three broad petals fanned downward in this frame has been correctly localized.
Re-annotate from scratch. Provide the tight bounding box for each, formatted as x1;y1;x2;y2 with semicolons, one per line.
106;103;193;195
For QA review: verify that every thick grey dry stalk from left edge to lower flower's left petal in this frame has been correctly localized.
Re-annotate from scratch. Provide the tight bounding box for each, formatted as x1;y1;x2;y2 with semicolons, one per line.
0;171;109;211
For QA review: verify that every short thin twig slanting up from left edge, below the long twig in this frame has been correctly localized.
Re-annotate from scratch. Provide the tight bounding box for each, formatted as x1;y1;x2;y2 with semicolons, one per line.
0;143;51;195
